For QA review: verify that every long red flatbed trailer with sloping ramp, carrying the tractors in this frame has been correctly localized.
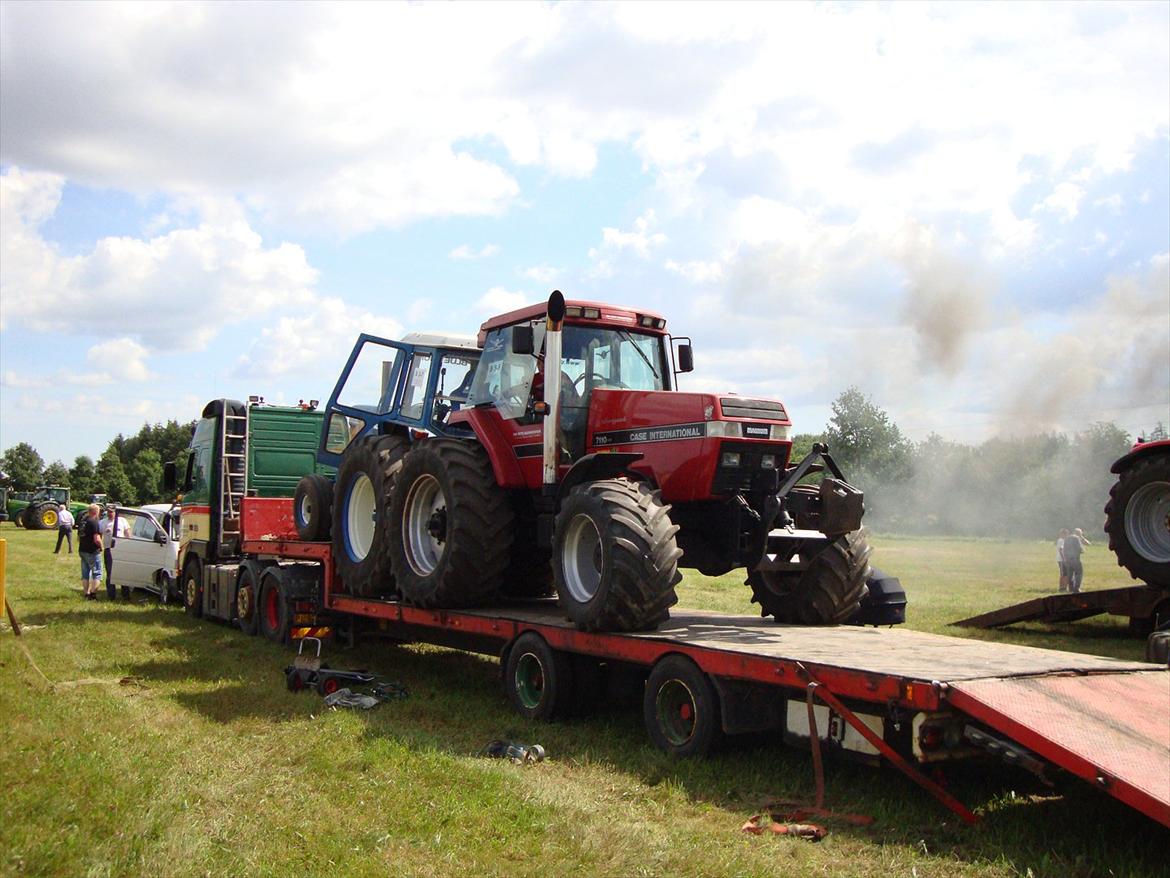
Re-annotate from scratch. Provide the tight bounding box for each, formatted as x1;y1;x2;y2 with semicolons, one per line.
241;526;1170;826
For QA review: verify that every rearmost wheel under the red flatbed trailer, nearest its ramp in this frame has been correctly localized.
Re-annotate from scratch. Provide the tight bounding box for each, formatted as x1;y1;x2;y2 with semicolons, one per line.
642;654;723;759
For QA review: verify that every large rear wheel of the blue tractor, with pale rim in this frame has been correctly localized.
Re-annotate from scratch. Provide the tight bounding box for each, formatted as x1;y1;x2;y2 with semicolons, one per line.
332;435;410;597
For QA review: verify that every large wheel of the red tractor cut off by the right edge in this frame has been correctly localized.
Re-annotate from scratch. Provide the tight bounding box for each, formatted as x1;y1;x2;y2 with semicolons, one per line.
1104;453;1170;588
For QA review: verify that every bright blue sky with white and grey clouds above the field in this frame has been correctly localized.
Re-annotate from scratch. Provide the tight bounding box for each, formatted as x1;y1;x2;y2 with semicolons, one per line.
0;0;1170;464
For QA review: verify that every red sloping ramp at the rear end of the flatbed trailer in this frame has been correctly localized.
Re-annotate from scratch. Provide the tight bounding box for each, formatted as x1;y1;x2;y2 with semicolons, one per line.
947;671;1170;826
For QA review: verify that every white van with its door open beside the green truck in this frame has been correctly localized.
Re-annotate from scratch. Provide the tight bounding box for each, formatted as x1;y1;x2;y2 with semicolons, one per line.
110;503;180;604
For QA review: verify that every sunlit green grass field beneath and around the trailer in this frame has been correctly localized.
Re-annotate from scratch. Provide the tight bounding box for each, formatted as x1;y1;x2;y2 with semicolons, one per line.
0;524;1170;877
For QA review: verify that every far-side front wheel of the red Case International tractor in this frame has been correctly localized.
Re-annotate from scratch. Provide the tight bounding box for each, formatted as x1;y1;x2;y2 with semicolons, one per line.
748;530;872;625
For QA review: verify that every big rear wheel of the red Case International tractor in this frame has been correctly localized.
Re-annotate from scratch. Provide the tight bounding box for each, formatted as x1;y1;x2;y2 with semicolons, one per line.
390;439;514;608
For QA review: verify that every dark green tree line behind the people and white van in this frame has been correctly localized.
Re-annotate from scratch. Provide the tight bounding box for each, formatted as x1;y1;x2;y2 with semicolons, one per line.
0;420;195;506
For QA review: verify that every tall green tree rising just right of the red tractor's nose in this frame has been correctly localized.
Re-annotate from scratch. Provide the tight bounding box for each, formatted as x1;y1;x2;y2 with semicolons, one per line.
825;387;911;482
